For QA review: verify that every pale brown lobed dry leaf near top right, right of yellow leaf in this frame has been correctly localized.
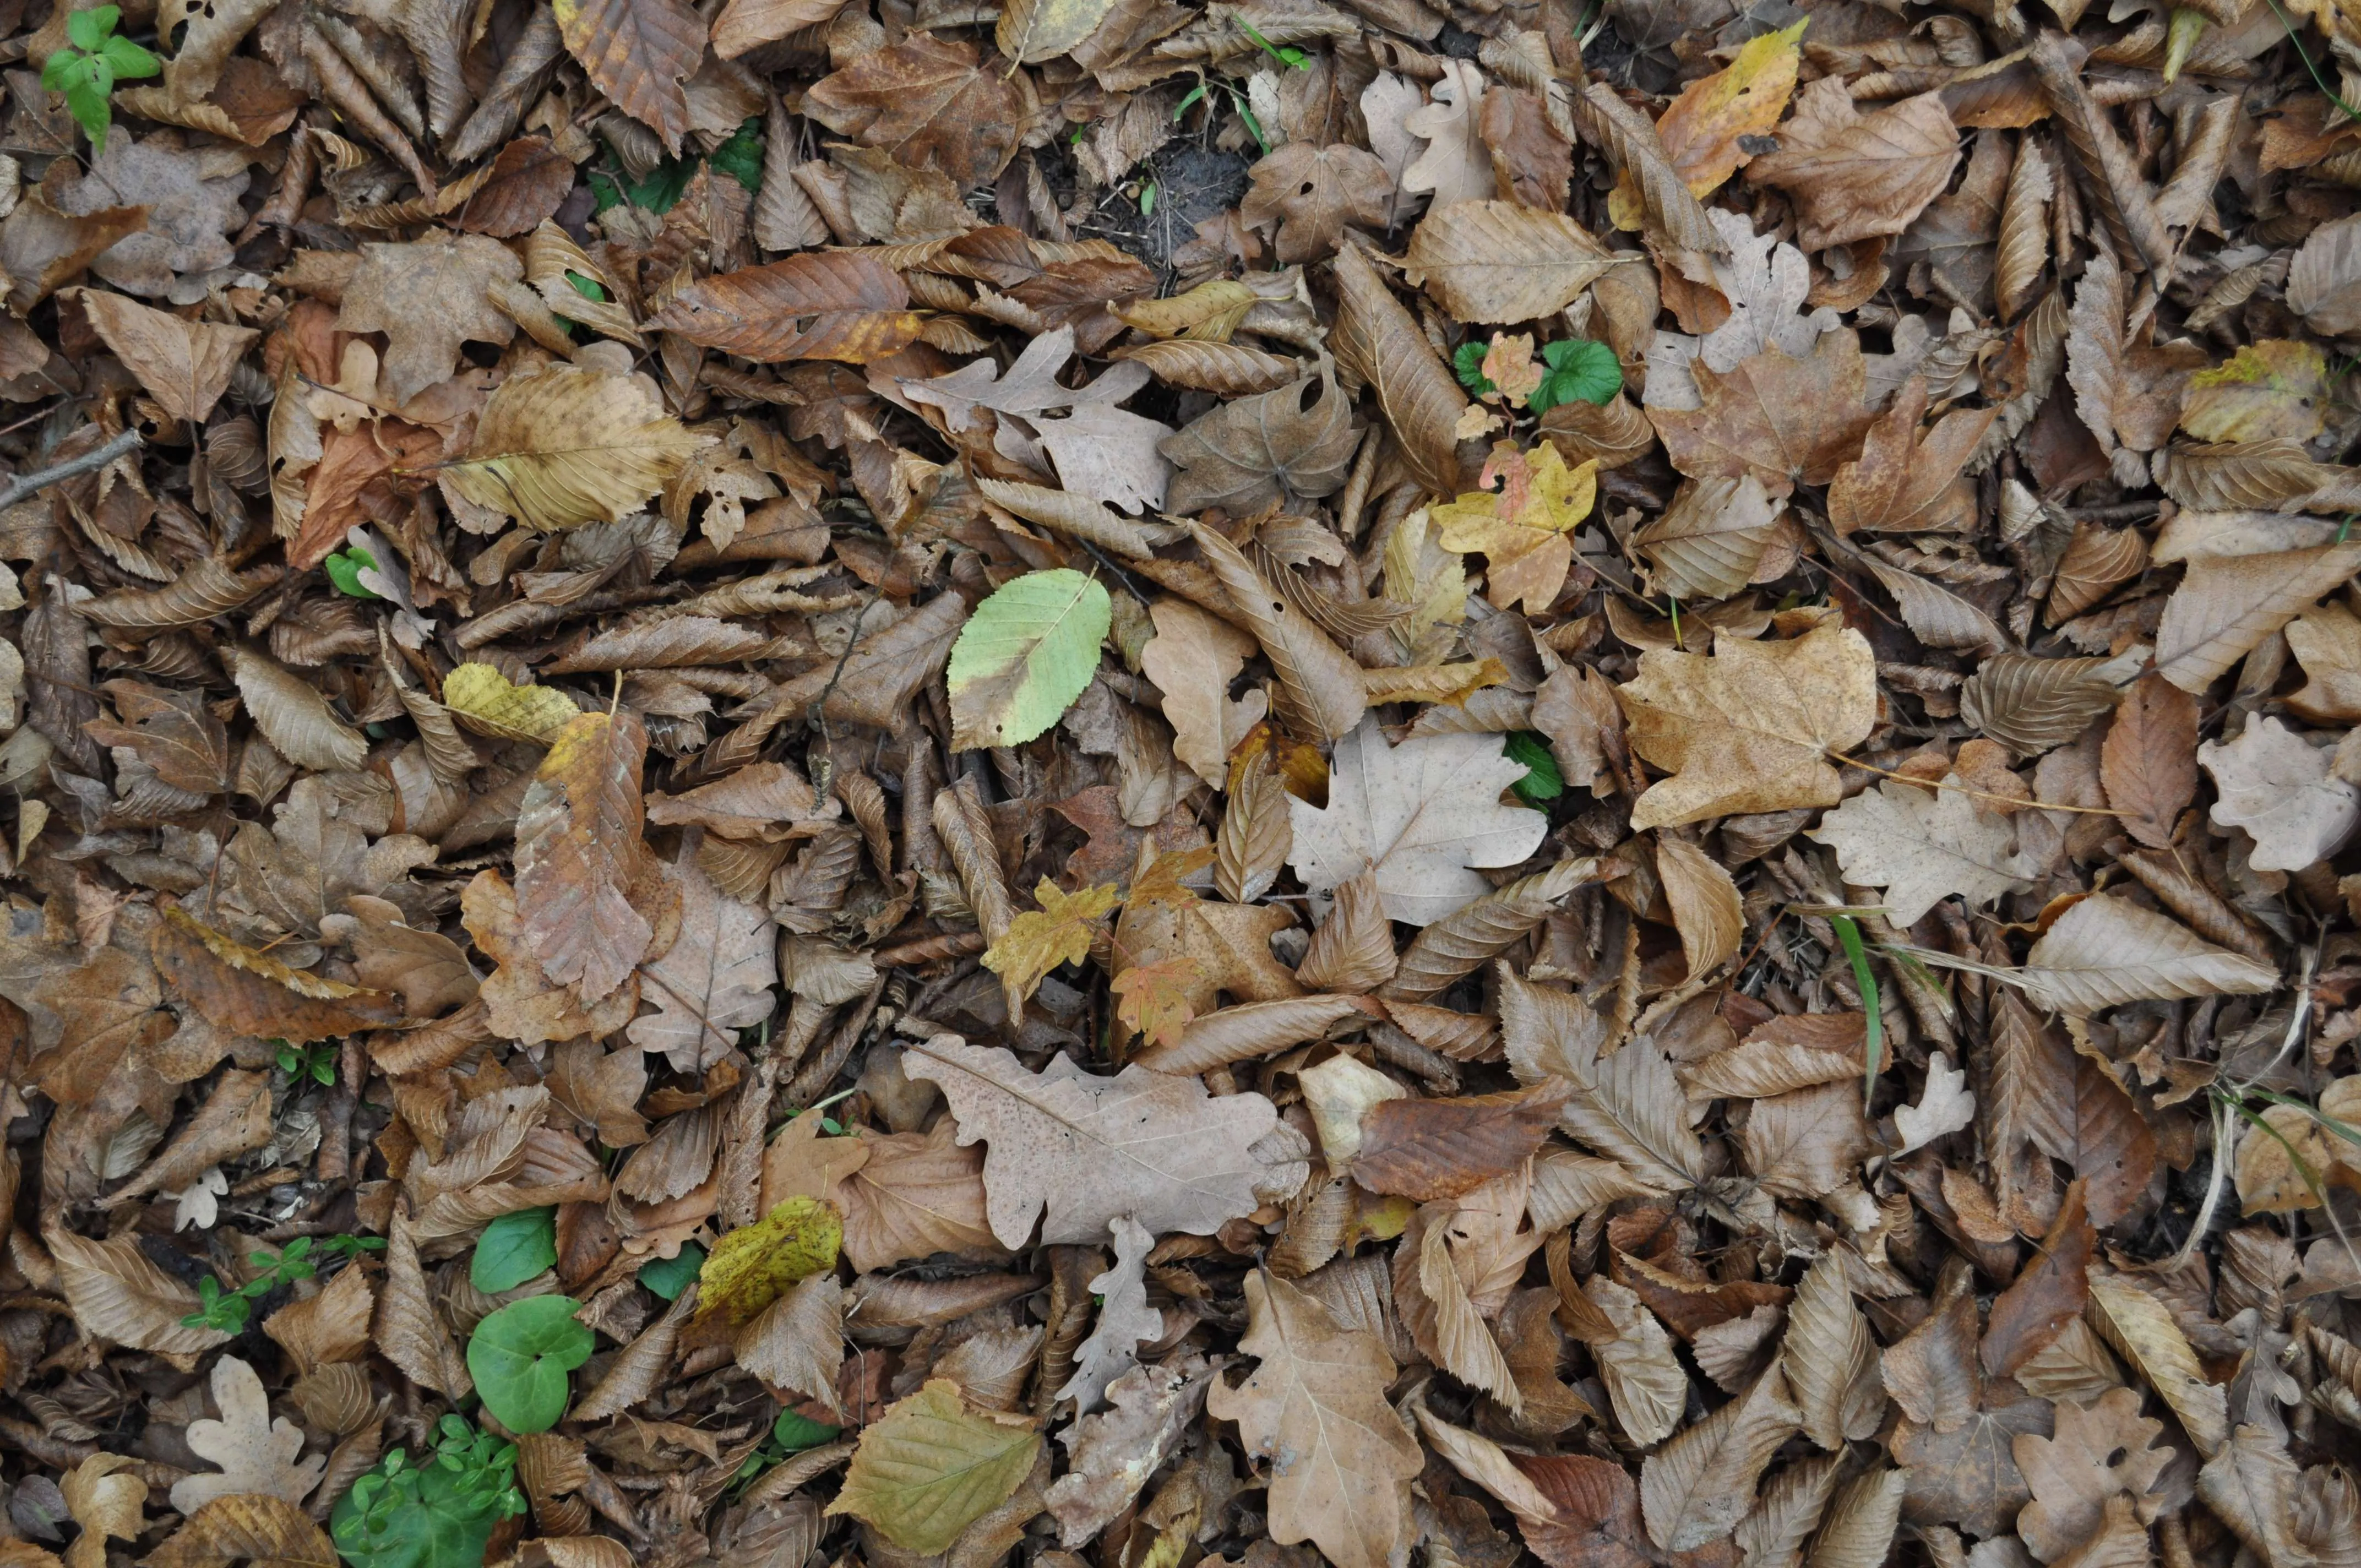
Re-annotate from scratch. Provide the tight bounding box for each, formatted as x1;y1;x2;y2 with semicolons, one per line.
1747;78;1960;251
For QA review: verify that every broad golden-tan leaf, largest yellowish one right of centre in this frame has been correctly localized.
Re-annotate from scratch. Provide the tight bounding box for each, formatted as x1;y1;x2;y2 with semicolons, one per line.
1615;623;1877;829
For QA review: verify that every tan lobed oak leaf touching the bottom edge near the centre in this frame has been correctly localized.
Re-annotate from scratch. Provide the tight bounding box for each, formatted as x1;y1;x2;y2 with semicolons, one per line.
1206;1273;1421;1568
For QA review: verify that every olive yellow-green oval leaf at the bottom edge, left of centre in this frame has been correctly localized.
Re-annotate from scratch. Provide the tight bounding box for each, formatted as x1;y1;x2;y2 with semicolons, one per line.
829;1377;1041;1556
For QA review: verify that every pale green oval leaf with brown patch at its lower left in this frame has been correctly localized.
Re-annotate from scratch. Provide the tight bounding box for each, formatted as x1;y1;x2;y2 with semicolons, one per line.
949;567;1114;751
